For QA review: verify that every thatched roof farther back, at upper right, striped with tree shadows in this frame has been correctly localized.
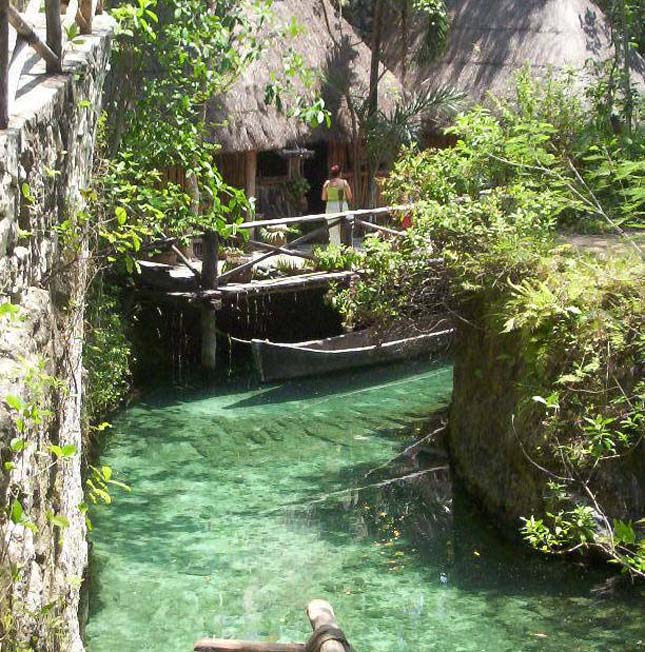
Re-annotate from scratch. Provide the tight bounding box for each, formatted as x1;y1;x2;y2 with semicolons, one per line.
385;0;643;102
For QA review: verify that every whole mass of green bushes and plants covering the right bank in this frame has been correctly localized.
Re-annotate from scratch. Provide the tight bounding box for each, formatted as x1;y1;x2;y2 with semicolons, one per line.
334;74;645;576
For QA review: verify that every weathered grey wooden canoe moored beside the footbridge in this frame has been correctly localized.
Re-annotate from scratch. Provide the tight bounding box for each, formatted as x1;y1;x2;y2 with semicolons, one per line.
251;328;454;383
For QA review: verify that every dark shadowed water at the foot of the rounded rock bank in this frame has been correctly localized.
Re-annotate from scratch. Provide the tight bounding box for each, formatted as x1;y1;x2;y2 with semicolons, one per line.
296;457;640;600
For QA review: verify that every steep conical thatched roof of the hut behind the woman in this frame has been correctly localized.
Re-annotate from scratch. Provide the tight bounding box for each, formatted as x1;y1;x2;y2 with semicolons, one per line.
208;0;401;152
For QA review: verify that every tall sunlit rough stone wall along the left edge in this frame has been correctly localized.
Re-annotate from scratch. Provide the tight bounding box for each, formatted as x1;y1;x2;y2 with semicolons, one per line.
0;16;112;652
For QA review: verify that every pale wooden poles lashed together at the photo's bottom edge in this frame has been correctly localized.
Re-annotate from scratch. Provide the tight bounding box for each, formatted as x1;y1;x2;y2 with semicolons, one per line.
194;599;351;652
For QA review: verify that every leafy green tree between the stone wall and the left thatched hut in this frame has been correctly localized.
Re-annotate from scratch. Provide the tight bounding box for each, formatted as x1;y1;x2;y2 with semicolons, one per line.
87;0;265;272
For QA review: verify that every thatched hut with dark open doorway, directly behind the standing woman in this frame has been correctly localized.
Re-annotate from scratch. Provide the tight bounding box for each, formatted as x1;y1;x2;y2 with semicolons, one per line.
207;0;401;216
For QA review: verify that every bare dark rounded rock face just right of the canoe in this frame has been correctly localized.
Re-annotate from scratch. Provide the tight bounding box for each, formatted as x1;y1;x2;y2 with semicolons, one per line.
449;304;545;531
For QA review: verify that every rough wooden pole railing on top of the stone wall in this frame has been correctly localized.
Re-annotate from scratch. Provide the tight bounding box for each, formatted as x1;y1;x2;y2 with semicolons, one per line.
0;0;102;129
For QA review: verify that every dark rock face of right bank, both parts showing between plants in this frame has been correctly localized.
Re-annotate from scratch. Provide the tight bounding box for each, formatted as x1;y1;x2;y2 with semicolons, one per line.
449;308;645;536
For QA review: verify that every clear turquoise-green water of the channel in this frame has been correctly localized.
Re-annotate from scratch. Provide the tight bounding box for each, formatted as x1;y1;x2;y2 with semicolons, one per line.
86;365;645;652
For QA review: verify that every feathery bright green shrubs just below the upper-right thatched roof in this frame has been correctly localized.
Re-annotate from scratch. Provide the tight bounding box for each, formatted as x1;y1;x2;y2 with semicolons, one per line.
388;72;645;231
